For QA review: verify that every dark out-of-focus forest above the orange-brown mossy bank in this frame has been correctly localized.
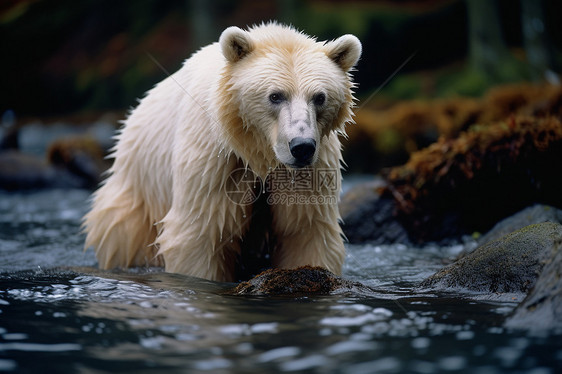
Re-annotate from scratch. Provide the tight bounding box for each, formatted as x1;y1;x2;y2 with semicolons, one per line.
0;0;562;117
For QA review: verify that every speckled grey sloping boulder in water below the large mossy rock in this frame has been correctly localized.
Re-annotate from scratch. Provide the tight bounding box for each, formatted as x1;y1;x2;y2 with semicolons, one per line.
420;222;562;294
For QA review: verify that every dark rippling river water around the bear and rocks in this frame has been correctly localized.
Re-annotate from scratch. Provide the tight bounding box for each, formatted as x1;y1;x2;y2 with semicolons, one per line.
0;190;562;374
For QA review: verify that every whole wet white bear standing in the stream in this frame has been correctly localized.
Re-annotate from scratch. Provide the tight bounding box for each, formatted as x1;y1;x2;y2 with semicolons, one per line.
84;23;361;281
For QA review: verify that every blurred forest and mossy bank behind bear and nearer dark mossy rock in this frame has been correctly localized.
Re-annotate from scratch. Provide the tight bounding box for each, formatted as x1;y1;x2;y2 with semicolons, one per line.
0;0;562;190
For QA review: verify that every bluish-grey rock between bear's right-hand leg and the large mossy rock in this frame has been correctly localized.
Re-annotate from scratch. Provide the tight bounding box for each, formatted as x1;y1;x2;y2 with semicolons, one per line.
340;179;409;245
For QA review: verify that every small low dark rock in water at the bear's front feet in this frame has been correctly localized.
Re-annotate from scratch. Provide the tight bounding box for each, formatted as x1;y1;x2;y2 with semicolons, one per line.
231;266;365;296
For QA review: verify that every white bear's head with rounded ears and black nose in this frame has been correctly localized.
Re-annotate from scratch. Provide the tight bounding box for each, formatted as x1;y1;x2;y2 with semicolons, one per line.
219;23;361;175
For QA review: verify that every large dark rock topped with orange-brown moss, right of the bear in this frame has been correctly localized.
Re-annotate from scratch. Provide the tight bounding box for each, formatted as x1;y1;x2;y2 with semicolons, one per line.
382;117;562;242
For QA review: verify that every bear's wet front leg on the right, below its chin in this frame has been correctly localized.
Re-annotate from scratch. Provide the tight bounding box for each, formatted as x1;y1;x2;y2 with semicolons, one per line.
266;169;345;275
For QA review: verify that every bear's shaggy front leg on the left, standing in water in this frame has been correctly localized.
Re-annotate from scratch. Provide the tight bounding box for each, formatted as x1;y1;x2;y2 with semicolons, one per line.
156;158;253;282
